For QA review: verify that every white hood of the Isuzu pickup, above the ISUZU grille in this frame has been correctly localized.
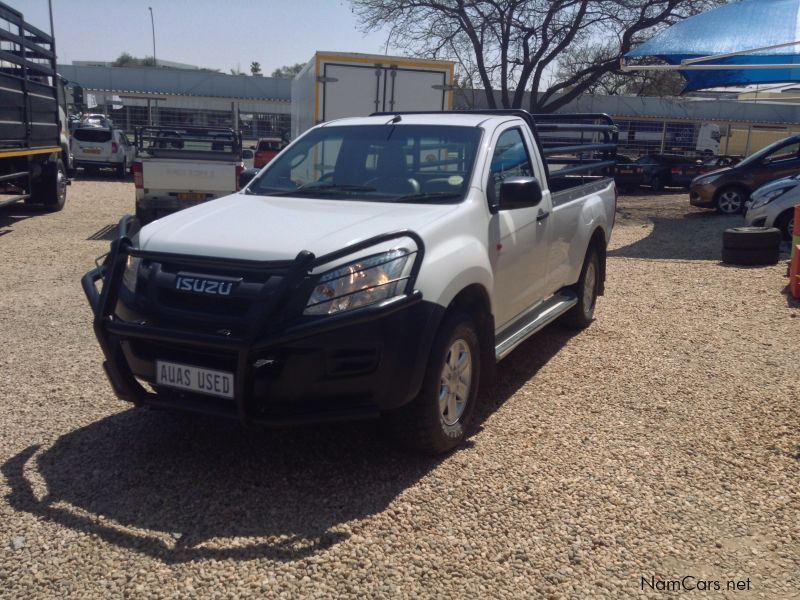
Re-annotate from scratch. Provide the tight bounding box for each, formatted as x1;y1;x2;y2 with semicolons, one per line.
138;194;457;260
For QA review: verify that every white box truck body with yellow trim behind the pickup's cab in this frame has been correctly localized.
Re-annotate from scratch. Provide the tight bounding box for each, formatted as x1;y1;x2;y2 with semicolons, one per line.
292;52;455;139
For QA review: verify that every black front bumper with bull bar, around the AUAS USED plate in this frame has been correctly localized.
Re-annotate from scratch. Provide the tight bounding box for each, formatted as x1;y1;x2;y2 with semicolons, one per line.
82;224;443;425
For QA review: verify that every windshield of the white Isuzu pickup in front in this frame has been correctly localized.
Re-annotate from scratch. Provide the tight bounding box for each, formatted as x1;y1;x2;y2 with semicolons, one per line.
246;124;481;203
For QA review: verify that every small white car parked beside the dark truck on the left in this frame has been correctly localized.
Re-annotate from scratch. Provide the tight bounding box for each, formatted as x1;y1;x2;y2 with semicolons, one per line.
72;127;136;177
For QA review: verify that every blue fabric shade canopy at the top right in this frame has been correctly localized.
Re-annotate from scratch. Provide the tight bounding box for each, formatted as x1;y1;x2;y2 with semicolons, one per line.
623;0;800;92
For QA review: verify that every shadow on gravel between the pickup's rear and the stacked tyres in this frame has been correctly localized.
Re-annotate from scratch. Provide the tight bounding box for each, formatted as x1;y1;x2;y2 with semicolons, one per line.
608;213;742;260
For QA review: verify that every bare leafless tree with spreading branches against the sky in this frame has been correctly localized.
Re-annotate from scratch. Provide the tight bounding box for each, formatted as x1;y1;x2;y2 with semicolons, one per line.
351;0;726;112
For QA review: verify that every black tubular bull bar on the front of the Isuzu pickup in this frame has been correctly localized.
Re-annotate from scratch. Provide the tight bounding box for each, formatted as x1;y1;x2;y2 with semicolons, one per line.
81;216;425;424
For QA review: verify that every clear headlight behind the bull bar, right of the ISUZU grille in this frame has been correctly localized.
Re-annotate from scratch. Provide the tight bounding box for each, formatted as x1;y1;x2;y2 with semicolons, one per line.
303;248;413;315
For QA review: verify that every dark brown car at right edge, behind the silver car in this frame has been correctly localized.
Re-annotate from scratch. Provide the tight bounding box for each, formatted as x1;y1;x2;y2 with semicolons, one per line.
689;135;800;214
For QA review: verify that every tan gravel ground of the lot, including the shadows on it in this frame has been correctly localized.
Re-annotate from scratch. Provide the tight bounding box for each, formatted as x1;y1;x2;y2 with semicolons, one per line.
0;179;800;599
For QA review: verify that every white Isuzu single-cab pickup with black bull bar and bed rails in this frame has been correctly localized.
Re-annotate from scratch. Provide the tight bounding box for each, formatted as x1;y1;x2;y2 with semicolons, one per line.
83;110;617;453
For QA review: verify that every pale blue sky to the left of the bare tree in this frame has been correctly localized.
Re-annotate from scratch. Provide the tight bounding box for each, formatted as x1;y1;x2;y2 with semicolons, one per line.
20;0;391;75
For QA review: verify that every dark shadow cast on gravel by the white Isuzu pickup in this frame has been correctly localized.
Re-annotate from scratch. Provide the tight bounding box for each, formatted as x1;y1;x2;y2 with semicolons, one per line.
0;327;574;564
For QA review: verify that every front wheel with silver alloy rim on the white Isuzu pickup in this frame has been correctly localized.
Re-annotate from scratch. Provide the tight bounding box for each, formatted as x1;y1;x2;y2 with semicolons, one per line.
386;312;481;455
